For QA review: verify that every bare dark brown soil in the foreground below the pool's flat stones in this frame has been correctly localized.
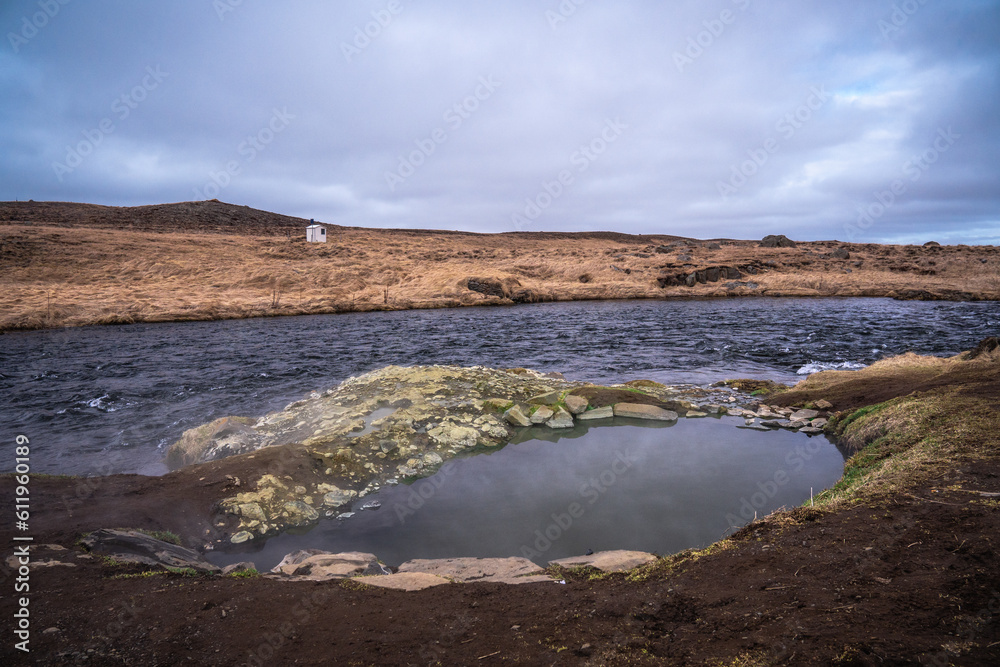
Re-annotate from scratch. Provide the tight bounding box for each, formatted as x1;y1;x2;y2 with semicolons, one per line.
0;460;1000;665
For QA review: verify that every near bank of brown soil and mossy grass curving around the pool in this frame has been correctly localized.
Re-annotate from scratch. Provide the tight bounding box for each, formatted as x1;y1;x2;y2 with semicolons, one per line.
2;341;1000;665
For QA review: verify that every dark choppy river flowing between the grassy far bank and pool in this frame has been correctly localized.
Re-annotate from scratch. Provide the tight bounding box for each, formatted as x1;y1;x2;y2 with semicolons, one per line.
0;298;1000;475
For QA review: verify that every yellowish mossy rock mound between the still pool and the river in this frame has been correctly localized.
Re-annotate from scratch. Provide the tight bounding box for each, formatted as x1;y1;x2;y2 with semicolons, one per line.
167;366;764;545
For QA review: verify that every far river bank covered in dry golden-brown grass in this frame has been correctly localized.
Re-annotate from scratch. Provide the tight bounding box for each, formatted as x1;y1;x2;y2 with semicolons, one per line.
0;201;1000;331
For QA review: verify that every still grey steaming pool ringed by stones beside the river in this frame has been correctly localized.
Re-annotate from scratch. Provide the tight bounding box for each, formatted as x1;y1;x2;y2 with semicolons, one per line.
211;417;844;570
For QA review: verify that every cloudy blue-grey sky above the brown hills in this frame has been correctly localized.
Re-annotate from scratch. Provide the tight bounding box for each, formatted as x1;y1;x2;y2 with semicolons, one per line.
0;0;1000;243
